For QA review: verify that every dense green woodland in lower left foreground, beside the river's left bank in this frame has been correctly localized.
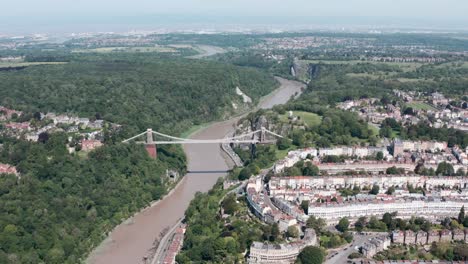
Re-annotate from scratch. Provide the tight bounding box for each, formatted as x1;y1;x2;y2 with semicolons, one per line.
0;134;185;264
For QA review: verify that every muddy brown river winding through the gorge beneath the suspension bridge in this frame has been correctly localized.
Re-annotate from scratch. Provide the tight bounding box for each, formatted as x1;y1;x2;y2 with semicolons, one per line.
88;77;305;264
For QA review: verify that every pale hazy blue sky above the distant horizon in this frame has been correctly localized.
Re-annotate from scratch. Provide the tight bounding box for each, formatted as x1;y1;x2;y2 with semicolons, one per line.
5;0;468;20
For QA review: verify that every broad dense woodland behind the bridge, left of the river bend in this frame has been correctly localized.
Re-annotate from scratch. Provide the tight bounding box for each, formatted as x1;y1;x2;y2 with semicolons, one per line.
0;54;277;133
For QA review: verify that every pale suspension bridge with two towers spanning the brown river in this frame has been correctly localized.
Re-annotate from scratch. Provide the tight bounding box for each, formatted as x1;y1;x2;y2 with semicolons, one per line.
122;127;283;158
